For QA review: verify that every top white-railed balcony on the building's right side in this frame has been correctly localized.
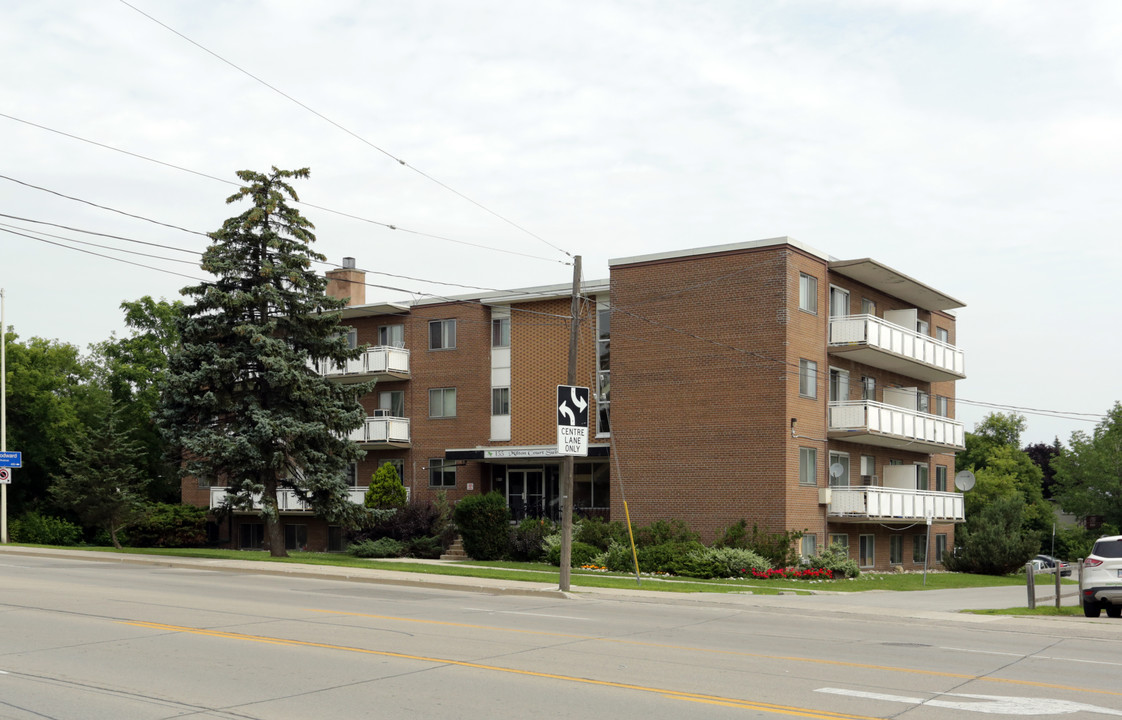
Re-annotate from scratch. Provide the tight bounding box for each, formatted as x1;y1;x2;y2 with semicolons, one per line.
827;315;966;382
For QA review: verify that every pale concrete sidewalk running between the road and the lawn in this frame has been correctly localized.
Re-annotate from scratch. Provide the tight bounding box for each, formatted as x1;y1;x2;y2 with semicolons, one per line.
0;545;1090;631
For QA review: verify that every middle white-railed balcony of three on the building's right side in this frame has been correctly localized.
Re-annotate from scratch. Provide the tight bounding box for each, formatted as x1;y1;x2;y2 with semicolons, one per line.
827;400;966;454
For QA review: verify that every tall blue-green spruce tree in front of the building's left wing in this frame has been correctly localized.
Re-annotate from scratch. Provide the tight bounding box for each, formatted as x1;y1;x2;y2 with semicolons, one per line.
157;167;374;557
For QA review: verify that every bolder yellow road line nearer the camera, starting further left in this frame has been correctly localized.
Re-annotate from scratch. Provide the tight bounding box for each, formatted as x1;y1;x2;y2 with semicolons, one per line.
121;620;881;720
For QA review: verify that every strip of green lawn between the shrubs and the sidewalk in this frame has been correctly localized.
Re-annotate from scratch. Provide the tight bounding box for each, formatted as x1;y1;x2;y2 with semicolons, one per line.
17;547;1041;592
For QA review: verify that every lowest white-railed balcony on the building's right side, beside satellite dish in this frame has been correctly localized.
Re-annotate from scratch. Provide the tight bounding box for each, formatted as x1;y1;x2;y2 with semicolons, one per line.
819;486;966;525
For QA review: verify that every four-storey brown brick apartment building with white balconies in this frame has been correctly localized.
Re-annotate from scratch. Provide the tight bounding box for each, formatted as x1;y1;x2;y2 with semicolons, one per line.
183;238;965;570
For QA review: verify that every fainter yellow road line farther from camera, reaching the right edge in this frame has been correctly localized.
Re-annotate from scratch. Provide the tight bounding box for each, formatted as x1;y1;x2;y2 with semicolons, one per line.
305;608;1122;695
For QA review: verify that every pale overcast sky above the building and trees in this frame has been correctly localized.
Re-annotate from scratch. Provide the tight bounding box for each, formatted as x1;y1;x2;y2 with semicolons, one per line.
0;0;1122;442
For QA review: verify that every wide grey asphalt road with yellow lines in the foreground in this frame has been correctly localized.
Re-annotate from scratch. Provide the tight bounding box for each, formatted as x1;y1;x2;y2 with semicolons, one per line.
0;542;1122;720
